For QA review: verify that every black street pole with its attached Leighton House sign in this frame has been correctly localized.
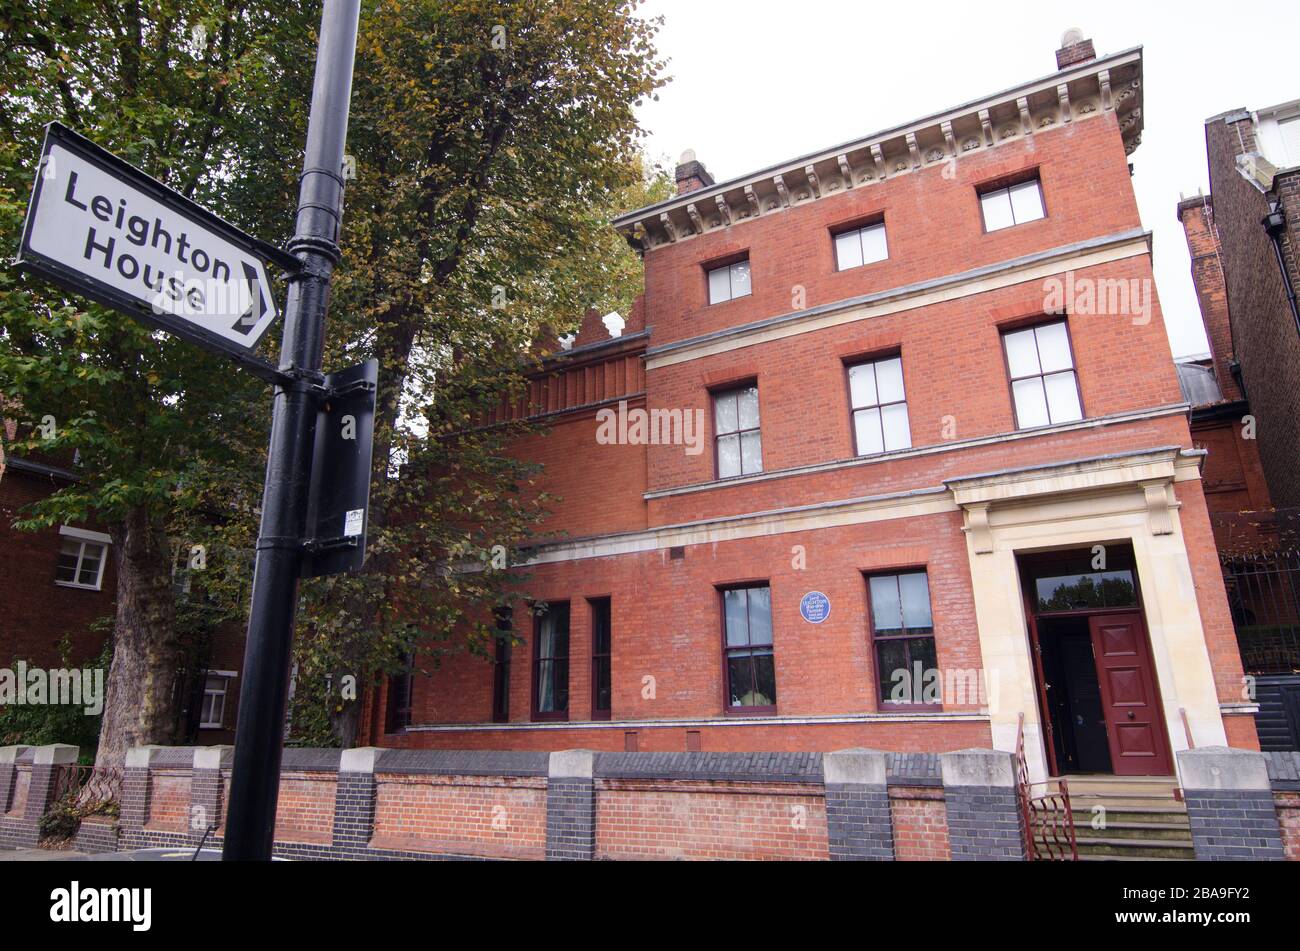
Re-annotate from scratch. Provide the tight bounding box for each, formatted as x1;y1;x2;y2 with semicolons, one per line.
16;0;366;860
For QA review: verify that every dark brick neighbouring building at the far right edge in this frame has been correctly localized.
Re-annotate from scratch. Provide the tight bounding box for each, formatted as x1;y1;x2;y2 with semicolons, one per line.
1178;103;1300;751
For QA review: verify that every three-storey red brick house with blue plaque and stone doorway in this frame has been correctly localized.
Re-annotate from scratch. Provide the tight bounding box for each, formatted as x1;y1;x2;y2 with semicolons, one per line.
363;40;1257;777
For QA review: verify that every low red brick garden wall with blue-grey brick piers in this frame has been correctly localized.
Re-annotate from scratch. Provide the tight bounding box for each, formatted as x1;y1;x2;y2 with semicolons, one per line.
0;746;1300;861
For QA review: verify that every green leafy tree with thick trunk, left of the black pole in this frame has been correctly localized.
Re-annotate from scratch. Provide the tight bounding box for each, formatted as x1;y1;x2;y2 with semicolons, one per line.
0;0;315;763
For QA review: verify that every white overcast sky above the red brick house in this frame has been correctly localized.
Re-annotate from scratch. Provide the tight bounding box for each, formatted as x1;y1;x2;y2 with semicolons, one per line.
641;0;1300;355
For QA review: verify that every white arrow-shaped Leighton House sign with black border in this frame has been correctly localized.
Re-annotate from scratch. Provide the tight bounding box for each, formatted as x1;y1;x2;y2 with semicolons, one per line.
18;122;299;368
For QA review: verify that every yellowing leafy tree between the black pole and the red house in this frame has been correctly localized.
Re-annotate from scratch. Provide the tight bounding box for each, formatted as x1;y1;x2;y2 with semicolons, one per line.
289;0;666;744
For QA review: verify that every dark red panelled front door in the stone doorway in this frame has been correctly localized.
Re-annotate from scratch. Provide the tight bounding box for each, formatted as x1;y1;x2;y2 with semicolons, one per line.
1089;613;1174;776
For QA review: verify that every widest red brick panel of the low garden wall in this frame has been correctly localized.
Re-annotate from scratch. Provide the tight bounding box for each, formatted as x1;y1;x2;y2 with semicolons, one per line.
595;780;828;860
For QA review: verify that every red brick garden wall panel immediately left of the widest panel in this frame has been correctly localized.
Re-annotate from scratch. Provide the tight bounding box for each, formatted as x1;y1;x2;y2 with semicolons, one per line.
371;773;546;859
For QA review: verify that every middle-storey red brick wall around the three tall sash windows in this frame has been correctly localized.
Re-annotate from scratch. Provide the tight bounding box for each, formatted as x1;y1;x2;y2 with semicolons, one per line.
644;252;1191;504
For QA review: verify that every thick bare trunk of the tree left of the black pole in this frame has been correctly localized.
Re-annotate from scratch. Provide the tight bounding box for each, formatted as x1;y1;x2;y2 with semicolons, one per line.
95;508;182;767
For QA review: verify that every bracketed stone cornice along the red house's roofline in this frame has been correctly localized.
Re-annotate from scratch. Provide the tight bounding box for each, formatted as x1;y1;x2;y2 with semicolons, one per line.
614;47;1143;251
